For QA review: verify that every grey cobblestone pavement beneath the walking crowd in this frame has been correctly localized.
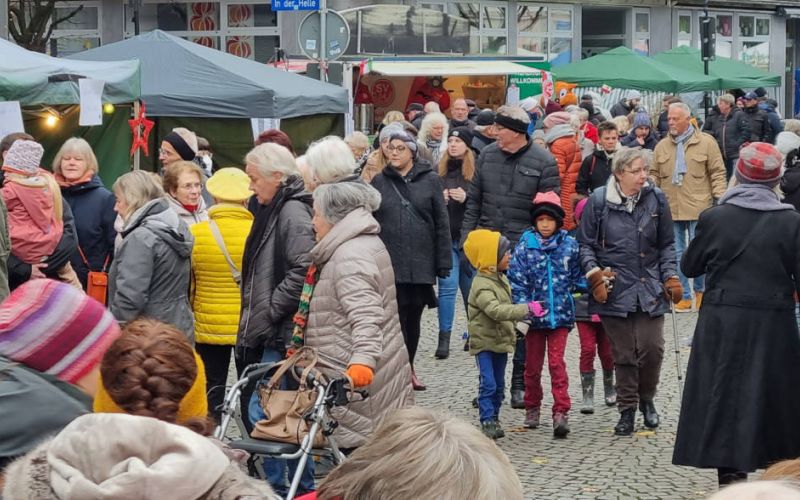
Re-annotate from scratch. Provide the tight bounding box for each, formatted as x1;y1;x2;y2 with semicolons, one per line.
415;309;716;499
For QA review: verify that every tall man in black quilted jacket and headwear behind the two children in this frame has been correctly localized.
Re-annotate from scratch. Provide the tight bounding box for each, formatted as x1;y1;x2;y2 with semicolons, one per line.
461;106;560;408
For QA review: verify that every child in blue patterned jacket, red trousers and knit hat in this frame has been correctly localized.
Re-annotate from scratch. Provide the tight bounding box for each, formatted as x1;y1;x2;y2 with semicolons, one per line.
508;192;586;438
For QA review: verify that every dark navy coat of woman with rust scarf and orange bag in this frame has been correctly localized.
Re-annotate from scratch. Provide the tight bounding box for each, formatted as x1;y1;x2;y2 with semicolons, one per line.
61;175;117;289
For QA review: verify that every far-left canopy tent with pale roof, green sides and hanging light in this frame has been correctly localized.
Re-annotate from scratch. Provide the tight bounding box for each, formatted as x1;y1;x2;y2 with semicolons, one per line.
0;39;141;185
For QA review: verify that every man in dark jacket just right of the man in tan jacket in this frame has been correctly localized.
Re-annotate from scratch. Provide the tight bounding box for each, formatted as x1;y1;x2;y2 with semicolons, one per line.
703;94;750;179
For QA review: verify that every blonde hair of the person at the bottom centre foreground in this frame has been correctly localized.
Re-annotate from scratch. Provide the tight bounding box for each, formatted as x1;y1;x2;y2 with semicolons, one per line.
317;407;522;500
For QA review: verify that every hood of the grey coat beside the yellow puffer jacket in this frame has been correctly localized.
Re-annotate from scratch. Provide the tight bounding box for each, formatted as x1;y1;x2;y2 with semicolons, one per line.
122;198;194;258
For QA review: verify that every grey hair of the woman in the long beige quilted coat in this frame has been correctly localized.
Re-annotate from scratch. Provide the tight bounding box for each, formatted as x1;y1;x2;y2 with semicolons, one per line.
314;180;381;225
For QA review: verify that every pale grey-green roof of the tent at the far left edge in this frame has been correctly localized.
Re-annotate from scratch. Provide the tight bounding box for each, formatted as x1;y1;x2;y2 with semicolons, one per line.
0;39;141;106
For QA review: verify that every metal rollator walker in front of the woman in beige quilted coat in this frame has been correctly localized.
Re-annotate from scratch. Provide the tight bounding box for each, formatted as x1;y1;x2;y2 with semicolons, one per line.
214;350;368;500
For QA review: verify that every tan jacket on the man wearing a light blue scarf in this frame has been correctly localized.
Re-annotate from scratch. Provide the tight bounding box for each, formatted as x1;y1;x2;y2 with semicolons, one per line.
651;130;727;221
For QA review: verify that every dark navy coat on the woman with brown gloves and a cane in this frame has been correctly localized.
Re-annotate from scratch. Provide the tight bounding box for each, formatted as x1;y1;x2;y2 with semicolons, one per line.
578;182;678;318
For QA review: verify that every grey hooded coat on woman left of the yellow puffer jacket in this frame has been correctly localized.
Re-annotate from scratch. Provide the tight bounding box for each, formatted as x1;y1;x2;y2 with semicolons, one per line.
108;198;194;342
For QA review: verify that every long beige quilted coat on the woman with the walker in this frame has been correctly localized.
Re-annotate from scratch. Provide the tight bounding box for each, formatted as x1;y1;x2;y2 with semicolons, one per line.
305;208;414;448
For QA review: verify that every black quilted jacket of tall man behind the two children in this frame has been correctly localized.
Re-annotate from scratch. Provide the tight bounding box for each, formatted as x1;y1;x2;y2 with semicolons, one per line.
461;142;561;245
